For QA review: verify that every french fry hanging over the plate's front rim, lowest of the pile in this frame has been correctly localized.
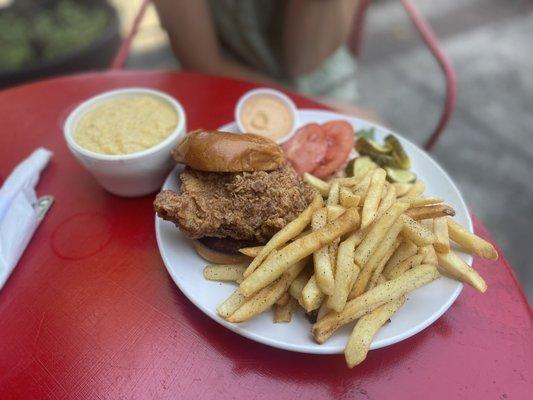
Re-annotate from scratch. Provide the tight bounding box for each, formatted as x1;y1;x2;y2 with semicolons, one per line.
344;296;405;368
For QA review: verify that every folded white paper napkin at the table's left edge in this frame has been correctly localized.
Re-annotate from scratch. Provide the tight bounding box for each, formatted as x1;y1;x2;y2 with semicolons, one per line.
0;148;52;289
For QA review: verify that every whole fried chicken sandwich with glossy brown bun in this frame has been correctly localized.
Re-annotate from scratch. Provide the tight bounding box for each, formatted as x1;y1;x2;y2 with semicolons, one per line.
154;130;314;264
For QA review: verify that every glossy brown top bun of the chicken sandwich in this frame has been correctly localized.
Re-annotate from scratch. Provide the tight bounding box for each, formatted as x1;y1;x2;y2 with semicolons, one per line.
172;130;285;172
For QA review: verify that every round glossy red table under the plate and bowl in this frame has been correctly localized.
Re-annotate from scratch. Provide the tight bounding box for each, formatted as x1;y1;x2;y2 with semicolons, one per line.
0;72;533;399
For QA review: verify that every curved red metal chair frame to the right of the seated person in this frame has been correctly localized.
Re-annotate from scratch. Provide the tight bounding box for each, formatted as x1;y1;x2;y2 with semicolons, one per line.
349;0;457;151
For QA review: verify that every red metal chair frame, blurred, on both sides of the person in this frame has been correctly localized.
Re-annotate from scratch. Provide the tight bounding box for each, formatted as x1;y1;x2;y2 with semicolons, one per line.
111;0;457;151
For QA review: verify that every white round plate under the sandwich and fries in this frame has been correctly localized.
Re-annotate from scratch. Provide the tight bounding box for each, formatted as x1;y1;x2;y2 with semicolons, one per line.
155;109;472;354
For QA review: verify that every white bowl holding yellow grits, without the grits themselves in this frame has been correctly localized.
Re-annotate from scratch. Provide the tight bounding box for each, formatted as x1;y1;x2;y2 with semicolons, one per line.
63;87;186;197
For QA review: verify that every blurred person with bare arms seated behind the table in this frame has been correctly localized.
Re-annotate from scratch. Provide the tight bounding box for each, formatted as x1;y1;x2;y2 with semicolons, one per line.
155;0;366;114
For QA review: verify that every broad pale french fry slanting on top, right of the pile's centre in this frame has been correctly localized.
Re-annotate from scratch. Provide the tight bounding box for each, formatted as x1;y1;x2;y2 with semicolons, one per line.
354;202;408;266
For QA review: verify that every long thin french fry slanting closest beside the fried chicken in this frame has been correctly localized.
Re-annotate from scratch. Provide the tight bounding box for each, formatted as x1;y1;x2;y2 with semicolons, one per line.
244;195;322;278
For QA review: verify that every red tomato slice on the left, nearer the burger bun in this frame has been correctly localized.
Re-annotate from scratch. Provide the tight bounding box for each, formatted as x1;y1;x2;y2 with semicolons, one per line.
281;124;328;175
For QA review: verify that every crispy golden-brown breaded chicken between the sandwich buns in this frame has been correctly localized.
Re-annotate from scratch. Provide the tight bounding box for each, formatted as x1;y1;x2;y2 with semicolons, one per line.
154;165;315;243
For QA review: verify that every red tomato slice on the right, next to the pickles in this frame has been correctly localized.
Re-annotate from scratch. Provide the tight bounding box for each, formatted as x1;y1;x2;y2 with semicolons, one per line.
312;121;355;178
